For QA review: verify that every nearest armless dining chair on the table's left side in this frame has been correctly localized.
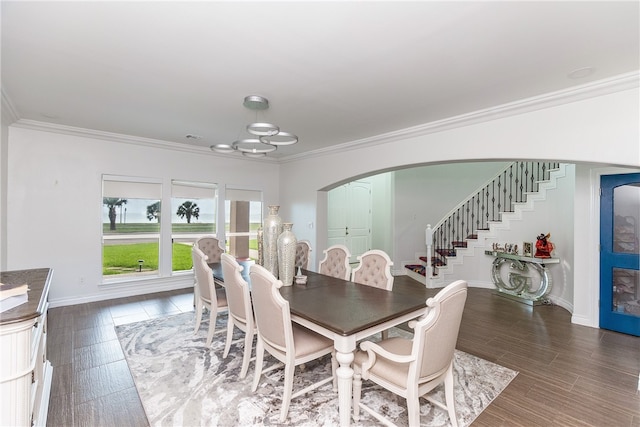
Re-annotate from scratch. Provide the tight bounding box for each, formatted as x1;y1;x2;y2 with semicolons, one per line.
249;265;337;423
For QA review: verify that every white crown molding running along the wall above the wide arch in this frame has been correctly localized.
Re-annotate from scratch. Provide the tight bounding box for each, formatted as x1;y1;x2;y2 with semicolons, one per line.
279;71;640;163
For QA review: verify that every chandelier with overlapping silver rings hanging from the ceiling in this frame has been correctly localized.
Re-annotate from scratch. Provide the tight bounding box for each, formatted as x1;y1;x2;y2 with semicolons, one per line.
210;95;298;157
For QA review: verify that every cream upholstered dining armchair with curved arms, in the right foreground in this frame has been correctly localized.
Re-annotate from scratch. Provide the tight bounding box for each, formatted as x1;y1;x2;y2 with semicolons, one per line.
353;280;467;427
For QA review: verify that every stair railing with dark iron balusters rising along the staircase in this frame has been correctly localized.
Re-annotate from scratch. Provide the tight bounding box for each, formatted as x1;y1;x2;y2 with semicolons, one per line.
427;162;560;268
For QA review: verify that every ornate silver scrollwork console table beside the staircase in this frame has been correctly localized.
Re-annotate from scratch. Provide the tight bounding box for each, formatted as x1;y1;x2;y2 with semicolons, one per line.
484;251;560;306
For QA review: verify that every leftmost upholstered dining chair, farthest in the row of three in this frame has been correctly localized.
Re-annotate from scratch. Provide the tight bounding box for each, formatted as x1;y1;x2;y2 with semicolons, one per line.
191;244;227;347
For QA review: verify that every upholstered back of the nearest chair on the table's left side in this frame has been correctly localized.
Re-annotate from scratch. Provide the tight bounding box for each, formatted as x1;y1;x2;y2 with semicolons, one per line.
249;265;293;354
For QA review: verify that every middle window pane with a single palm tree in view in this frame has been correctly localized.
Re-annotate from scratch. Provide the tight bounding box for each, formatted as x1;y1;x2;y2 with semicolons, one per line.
171;181;218;272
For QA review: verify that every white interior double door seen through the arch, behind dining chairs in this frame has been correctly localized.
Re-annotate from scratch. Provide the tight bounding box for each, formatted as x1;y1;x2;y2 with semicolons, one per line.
327;181;371;262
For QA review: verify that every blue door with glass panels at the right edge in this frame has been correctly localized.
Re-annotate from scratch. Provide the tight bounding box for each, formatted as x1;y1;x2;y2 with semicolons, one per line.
600;173;640;336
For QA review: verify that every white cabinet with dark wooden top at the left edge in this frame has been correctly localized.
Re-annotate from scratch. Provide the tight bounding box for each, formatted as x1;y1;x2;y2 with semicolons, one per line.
0;268;53;426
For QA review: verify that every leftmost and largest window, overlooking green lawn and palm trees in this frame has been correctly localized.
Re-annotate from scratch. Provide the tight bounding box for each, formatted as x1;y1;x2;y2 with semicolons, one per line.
102;175;162;279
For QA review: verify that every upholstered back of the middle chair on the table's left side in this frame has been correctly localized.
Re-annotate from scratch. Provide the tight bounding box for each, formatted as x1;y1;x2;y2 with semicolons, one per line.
220;253;253;324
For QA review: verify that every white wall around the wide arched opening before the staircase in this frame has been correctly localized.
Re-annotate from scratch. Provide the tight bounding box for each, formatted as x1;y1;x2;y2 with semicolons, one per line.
280;88;640;326
